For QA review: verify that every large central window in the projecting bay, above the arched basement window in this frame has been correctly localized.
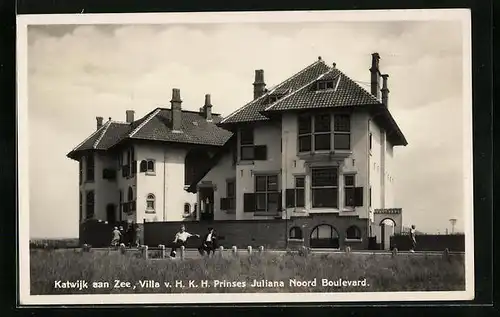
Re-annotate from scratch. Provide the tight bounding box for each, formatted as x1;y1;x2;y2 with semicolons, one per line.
311;167;338;208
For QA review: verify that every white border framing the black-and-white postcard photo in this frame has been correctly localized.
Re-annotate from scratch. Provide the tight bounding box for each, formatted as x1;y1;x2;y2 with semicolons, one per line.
17;9;474;305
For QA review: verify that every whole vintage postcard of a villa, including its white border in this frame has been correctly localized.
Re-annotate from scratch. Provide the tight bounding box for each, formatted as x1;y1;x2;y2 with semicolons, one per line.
17;10;474;305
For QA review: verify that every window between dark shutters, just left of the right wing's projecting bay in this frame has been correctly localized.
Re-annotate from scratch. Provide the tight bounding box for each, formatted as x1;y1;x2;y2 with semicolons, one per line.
255;175;281;212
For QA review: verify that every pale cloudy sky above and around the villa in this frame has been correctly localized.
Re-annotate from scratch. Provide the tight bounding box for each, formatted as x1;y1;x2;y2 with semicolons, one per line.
28;15;466;238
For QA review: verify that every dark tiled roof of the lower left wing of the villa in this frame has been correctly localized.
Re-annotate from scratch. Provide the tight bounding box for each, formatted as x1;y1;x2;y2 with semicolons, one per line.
68;108;232;158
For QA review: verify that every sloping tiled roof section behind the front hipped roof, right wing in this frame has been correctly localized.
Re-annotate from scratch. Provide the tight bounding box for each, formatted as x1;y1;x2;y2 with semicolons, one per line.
221;59;330;124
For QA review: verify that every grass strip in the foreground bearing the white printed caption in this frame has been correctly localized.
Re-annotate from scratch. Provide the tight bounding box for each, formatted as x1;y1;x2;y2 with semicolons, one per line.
30;249;465;295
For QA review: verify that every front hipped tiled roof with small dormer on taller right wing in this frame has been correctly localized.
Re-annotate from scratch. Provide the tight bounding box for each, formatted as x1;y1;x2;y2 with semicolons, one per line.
262;68;381;113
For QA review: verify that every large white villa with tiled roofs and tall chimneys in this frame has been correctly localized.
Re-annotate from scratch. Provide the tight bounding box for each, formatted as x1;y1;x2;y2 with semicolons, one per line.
68;53;407;247
